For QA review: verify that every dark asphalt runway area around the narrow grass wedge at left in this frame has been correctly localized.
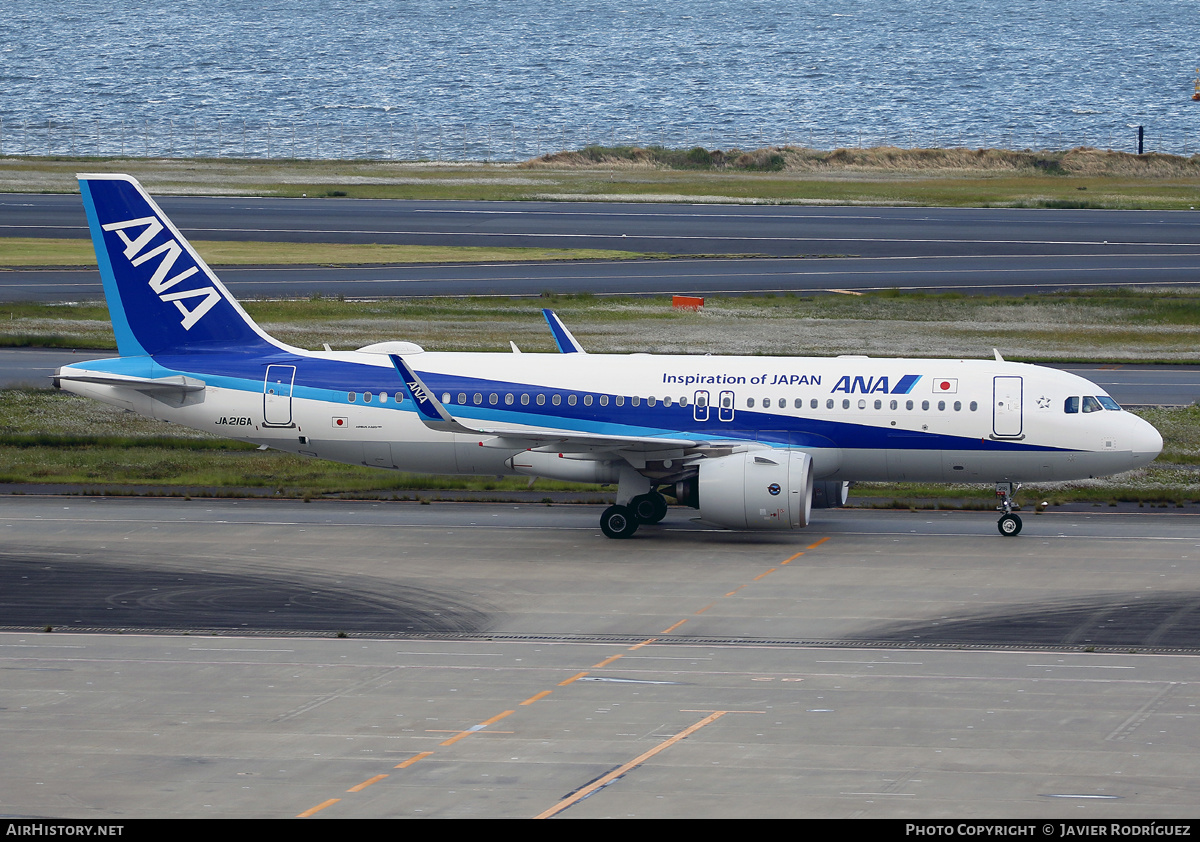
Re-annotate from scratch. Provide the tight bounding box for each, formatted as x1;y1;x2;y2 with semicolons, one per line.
7;194;1200;301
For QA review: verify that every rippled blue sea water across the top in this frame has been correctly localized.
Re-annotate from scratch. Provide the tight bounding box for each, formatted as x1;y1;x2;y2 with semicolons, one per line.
0;0;1200;160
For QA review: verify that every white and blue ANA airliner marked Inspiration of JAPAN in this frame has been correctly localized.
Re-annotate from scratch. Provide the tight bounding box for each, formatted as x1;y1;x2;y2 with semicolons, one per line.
54;174;1163;537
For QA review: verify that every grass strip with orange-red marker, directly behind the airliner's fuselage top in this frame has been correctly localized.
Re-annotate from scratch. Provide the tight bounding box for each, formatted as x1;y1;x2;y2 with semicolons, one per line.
0;289;1200;363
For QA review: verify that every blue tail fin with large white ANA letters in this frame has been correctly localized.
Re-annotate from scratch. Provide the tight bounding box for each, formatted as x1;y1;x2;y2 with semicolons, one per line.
78;174;280;356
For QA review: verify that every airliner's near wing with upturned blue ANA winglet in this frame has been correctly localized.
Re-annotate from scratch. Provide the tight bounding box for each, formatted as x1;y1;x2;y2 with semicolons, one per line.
388;354;709;452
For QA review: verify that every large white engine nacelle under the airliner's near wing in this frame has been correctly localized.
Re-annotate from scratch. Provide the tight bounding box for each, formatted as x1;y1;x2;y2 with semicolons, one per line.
679;450;812;529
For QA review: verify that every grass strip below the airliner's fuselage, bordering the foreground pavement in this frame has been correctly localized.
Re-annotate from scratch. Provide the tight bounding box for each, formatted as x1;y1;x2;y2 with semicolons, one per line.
0;390;1200;509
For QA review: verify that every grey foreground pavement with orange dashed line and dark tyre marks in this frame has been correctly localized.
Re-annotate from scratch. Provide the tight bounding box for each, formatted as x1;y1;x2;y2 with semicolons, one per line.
0;498;1200;819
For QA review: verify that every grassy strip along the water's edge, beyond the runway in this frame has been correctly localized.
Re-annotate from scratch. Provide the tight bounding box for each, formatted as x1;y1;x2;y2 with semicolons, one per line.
0;146;1200;212
